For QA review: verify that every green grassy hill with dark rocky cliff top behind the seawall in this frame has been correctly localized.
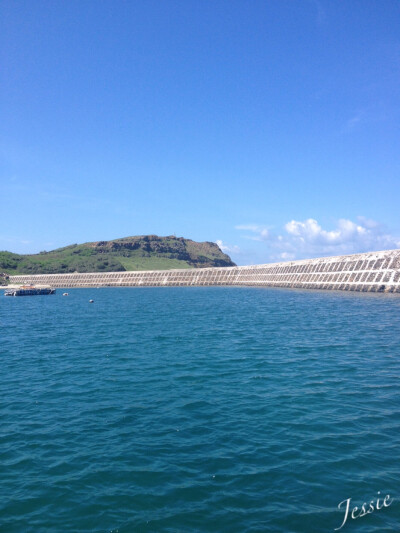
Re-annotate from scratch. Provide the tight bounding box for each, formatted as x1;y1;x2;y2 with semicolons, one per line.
0;235;235;275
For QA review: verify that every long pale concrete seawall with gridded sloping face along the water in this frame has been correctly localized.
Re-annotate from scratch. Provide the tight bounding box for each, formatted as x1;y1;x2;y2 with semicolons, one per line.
10;250;400;293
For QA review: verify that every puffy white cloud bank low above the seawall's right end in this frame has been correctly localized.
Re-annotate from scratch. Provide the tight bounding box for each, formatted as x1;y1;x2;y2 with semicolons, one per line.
237;217;400;260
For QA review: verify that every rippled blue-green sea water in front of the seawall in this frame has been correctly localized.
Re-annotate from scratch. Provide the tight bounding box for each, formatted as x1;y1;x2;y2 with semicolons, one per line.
0;287;400;533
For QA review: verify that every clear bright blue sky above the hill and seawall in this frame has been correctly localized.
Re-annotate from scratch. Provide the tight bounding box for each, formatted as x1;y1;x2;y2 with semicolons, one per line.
0;0;400;264
